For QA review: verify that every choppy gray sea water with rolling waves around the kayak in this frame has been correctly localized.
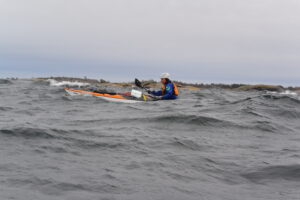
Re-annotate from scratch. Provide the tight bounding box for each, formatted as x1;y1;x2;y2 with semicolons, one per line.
0;80;300;200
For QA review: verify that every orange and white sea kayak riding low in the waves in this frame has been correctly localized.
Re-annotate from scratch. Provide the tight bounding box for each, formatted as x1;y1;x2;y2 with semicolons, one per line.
65;88;154;103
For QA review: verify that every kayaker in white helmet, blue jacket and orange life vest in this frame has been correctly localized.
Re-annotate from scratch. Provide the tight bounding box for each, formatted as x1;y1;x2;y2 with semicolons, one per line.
148;73;179;100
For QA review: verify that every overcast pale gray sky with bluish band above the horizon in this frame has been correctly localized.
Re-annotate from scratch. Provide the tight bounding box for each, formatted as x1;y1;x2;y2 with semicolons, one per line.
0;0;300;85
